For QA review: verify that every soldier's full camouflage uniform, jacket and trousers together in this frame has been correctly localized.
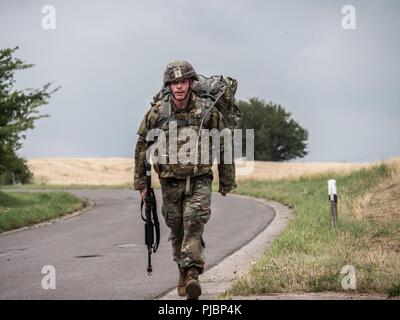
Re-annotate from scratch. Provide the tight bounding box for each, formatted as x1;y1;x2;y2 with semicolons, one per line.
134;60;236;273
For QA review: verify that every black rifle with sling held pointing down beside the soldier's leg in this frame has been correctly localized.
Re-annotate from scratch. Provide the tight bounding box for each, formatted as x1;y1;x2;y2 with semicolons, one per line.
140;161;160;276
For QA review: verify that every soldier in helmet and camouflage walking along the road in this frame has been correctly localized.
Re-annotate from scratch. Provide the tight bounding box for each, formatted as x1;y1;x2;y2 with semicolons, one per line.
134;61;236;299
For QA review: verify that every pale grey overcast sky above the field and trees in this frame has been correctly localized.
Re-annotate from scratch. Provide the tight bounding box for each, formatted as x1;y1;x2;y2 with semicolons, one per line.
0;0;400;161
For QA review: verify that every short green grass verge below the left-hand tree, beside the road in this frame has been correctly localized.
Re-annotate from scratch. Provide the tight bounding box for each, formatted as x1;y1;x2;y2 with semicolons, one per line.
0;191;84;233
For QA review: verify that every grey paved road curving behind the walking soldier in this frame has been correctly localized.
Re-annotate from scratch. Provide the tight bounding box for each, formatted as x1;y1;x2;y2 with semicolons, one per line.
0;190;274;299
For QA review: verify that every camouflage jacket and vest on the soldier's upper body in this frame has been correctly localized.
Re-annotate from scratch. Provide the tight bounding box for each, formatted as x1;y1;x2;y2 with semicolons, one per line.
133;92;236;191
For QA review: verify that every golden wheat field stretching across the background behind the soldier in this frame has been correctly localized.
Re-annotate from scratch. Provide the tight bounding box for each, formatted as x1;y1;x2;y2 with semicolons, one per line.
28;158;400;186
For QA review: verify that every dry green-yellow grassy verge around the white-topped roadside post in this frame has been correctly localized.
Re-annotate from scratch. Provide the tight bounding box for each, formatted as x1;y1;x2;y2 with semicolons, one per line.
227;164;400;296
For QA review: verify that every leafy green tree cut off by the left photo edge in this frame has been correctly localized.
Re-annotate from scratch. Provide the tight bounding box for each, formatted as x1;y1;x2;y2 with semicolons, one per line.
0;47;59;183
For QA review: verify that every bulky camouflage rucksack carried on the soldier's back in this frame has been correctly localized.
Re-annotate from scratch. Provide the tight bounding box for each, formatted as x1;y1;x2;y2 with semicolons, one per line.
153;75;241;131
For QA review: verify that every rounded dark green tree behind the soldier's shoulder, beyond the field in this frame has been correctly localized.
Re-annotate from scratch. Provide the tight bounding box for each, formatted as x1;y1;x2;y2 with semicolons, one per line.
239;98;308;161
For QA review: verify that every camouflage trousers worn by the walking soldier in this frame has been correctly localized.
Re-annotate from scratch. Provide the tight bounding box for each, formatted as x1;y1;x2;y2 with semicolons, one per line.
160;173;213;273
